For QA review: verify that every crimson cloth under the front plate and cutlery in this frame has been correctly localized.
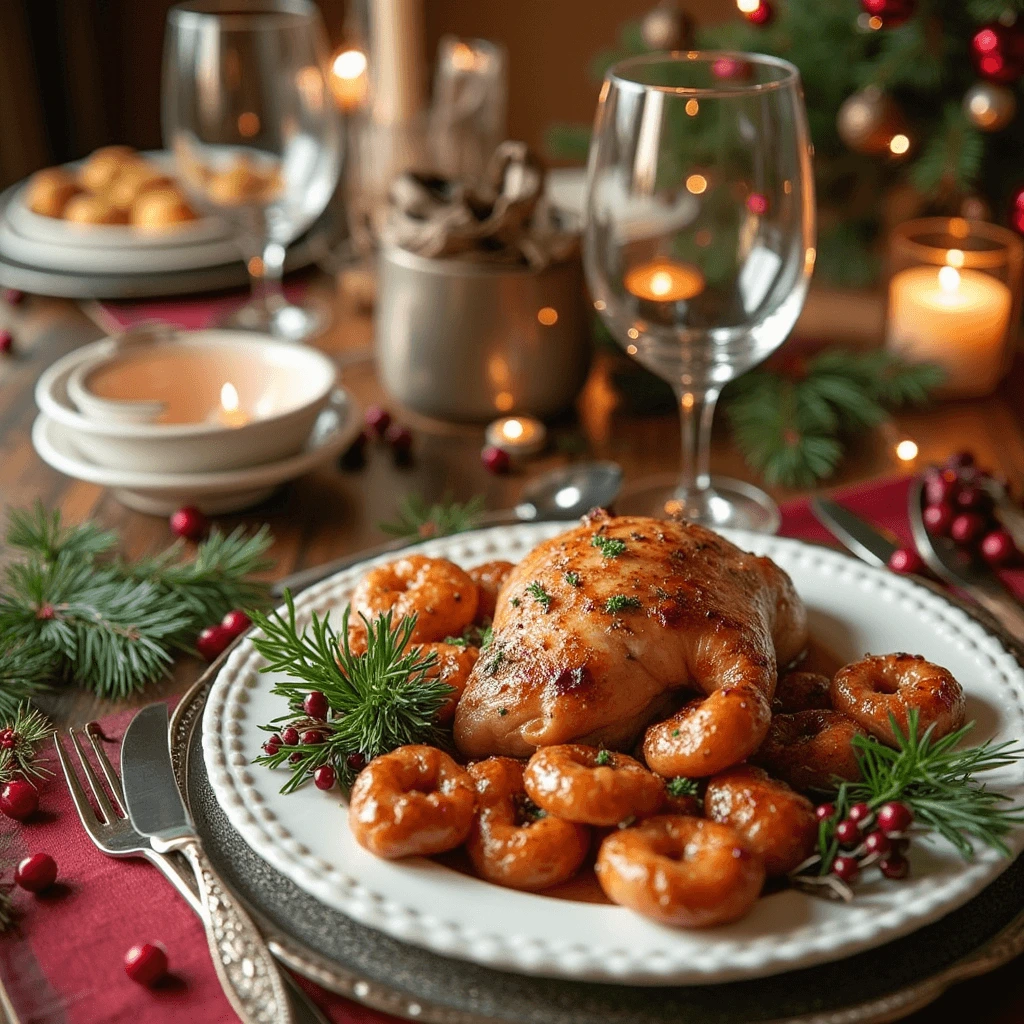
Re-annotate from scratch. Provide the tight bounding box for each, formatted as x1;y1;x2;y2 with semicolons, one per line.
0;478;1011;1024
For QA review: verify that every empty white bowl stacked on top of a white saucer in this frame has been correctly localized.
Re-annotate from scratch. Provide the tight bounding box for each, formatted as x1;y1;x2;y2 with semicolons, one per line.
36;330;337;473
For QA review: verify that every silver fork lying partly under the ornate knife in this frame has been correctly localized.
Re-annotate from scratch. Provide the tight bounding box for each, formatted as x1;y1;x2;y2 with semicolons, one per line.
53;722;331;1024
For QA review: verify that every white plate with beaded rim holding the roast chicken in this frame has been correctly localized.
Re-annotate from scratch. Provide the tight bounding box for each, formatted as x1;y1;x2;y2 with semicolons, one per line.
203;523;1024;985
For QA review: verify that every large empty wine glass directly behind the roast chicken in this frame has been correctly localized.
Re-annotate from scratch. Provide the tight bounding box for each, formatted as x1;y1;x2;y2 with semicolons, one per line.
584;51;815;531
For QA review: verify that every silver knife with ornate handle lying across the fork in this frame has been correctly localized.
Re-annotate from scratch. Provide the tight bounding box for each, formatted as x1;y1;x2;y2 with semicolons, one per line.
121;703;292;1024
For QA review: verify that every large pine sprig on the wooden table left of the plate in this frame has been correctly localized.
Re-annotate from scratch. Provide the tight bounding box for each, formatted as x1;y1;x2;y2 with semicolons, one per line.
0;503;270;714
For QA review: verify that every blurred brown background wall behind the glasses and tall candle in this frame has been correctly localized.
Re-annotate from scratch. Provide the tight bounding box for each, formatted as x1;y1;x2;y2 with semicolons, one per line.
0;0;735;185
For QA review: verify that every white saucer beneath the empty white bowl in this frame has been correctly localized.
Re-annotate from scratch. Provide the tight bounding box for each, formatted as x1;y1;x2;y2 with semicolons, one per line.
32;389;362;515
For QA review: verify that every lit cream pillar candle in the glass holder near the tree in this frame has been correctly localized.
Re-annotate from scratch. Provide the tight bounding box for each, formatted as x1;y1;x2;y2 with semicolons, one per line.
888;265;1013;395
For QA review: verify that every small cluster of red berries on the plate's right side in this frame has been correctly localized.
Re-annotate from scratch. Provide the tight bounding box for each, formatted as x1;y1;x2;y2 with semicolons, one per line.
815;801;913;885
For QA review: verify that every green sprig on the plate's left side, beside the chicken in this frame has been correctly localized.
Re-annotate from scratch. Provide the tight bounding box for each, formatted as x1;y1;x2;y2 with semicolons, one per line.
252;591;452;793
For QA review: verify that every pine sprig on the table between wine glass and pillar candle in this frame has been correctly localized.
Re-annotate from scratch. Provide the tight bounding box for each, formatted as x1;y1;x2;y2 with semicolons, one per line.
727;349;943;487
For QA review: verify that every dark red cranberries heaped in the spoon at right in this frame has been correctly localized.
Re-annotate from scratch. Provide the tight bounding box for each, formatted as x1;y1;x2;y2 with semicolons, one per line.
923;452;1018;566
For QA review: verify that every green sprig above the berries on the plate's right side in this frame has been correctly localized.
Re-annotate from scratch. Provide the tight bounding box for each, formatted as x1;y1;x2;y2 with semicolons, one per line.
816;710;1024;874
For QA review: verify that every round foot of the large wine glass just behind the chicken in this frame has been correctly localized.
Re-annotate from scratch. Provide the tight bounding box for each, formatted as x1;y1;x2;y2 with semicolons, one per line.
615;474;782;534
